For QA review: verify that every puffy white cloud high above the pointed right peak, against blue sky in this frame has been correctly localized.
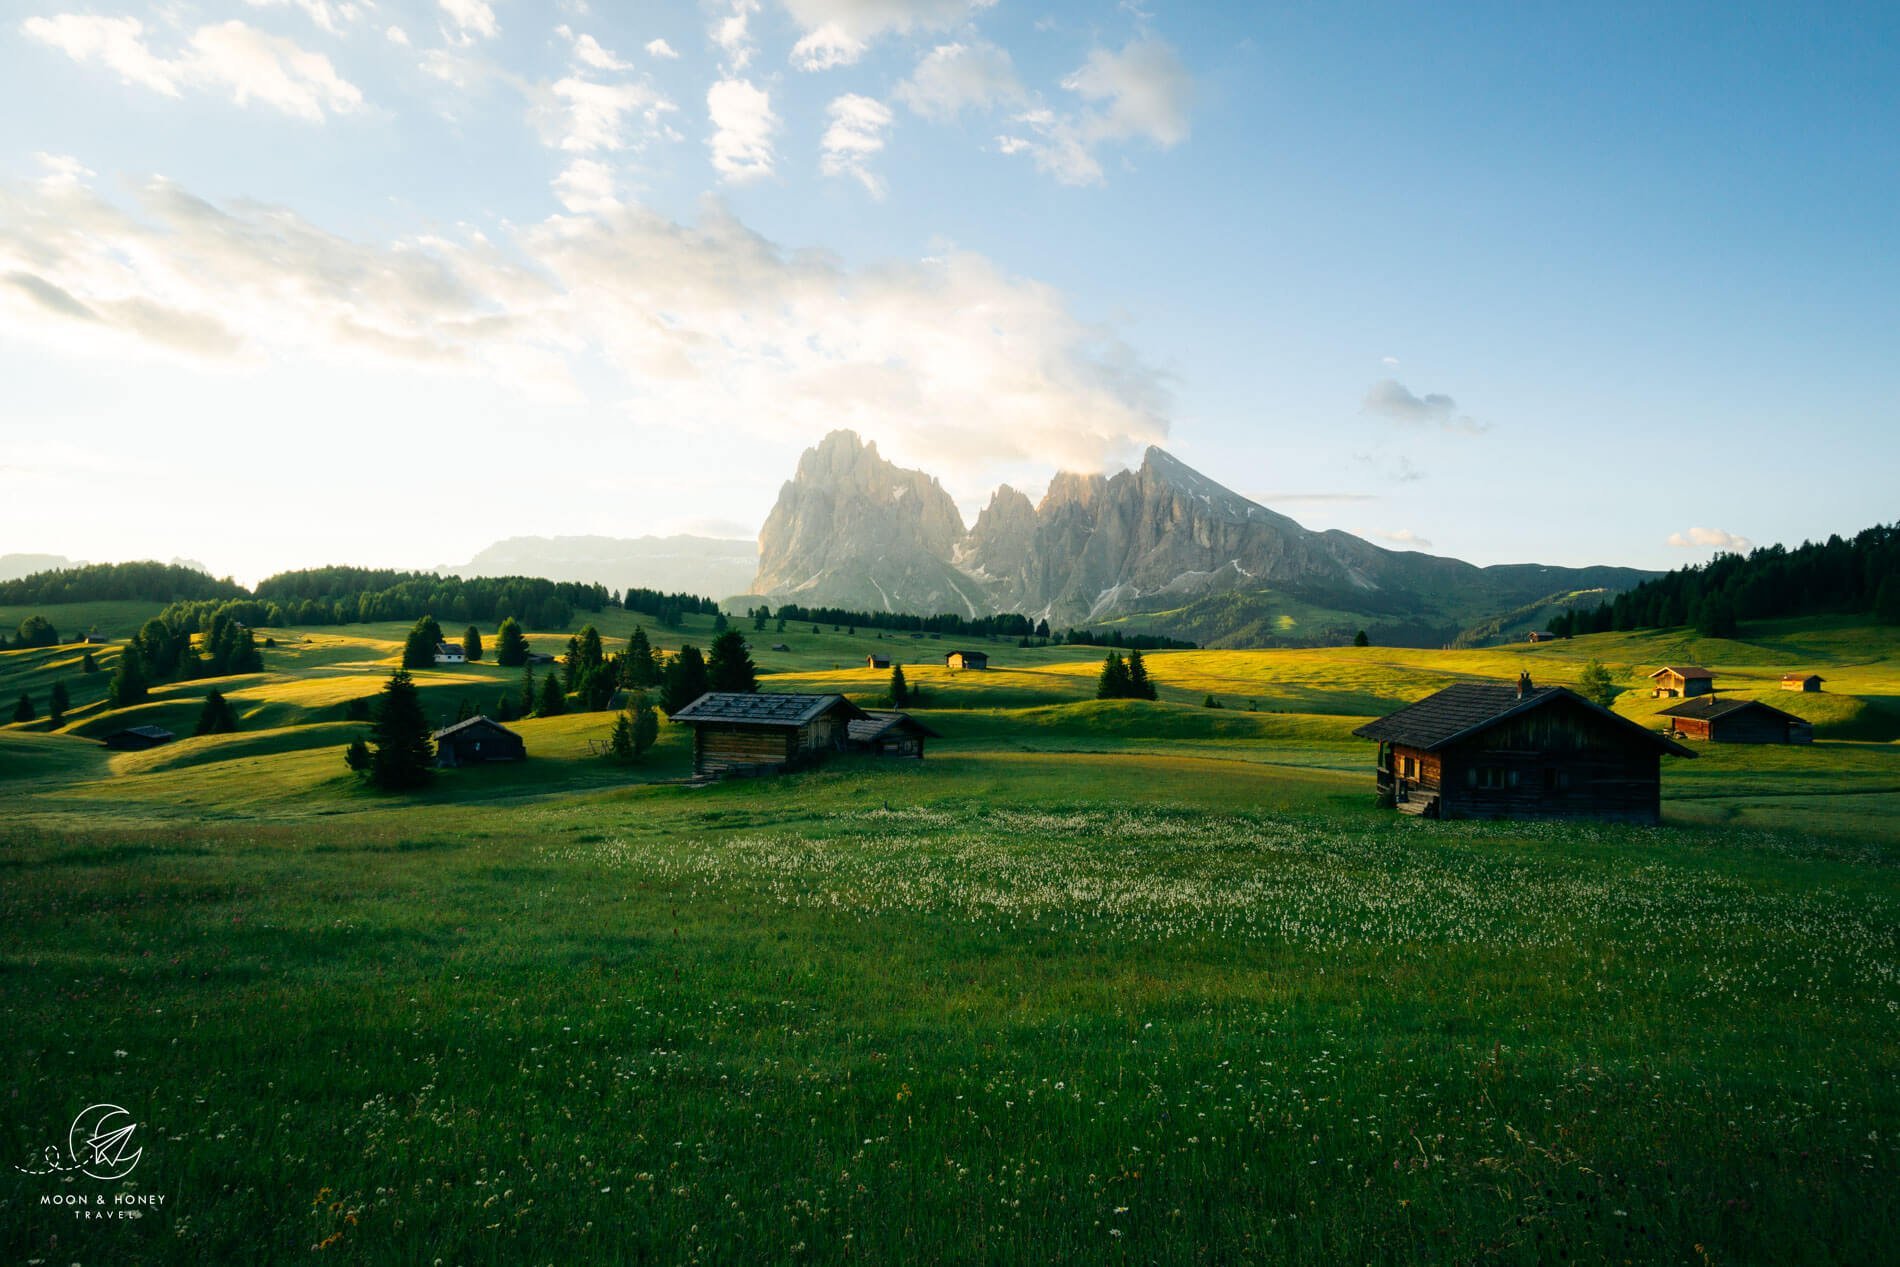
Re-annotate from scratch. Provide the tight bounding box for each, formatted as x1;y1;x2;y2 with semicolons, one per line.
996;36;1193;184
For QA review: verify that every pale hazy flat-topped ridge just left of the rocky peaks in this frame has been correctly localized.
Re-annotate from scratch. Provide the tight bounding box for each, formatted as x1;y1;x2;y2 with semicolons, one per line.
435;536;758;596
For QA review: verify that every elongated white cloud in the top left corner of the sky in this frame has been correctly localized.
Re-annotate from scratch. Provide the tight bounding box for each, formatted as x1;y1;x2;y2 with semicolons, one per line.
21;13;363;123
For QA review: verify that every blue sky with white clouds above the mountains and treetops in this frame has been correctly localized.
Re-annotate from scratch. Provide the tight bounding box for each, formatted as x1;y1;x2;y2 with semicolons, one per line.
0;0;1900;581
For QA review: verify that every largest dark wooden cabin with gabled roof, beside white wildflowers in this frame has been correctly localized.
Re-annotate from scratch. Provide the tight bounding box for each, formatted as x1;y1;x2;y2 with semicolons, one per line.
1353;674;1695;823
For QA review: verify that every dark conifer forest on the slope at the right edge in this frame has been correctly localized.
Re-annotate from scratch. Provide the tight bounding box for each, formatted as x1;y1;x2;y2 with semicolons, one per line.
1550;522;1900;638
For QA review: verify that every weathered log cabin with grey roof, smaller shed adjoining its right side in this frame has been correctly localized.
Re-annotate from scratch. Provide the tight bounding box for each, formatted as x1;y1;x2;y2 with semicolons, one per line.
673;691;865;777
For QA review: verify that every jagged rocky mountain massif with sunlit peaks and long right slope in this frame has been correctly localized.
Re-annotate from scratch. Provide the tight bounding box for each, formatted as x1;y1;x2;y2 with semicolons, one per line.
751;431;1655;646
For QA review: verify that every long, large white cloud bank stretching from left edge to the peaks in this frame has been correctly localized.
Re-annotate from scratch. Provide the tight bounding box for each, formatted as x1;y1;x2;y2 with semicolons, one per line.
0;160;1167;482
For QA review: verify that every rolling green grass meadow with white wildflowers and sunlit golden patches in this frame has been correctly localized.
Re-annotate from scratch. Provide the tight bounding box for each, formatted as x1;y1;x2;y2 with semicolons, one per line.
0;610;1900;1263
